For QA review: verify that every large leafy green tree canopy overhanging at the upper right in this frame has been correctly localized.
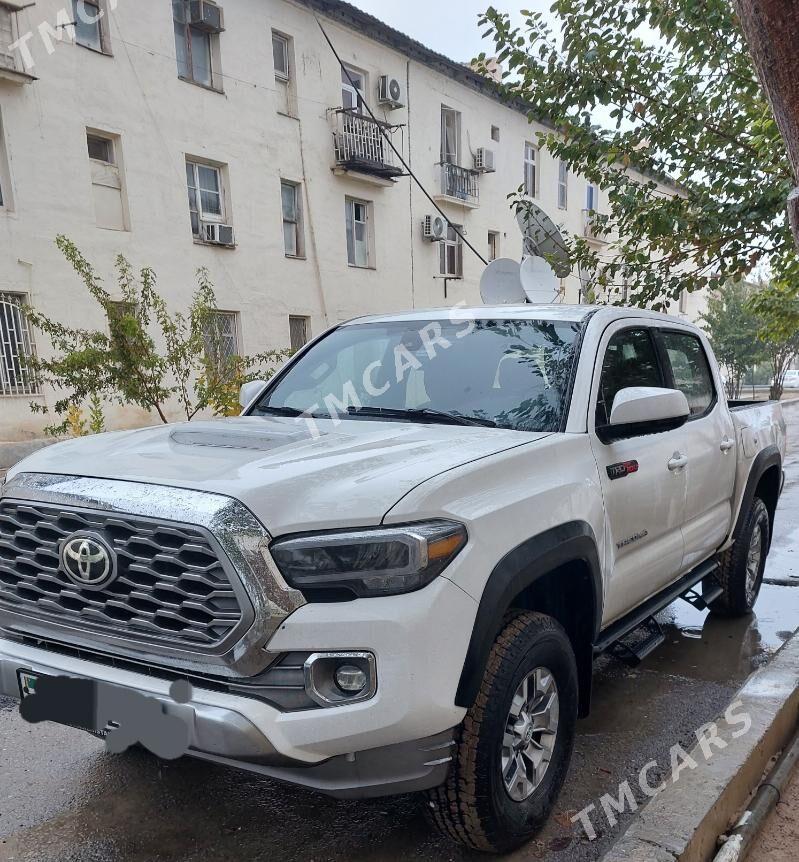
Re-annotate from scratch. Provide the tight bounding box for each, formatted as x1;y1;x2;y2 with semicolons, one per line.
478;0;799;308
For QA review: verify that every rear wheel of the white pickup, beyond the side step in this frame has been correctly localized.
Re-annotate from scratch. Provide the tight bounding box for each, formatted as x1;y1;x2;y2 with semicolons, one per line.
710;497;771;617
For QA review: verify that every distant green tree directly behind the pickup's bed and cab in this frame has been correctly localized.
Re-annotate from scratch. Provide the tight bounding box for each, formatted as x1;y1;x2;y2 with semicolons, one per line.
702;281;766;399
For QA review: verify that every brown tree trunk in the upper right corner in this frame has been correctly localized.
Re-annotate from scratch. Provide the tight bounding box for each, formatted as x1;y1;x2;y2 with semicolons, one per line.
735;0;799;246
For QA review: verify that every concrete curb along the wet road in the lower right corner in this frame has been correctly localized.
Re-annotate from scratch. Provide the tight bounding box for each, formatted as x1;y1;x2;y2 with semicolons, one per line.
602;634;799;862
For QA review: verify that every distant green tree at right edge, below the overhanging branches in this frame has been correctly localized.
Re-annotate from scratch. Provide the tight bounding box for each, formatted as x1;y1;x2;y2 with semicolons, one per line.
748;283;799;400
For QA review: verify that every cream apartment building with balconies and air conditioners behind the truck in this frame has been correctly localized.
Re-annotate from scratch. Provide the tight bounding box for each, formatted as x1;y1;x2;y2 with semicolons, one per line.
0;0;708;440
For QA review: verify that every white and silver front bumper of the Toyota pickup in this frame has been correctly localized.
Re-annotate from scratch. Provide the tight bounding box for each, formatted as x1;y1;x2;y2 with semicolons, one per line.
0;577;476;797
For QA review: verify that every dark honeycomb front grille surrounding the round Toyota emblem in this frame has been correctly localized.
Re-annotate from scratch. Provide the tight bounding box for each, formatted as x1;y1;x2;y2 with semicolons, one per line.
0;500;247;648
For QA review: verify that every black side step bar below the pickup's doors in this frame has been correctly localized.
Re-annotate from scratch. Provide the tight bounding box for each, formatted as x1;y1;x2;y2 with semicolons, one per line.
594;560;722;665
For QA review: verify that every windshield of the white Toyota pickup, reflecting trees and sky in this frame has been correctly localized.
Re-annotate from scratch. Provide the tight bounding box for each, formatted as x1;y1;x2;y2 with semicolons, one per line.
252;320;580;431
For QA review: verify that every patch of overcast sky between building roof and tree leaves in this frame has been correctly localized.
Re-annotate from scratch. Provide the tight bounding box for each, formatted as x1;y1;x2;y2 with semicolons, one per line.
350;0;552;62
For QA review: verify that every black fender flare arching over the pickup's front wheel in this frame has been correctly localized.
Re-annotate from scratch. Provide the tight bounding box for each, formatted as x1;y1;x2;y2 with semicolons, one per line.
455;521;603;714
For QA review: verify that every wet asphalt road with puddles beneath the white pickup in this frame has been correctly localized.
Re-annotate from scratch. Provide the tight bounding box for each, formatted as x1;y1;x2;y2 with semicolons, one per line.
0;404;799;862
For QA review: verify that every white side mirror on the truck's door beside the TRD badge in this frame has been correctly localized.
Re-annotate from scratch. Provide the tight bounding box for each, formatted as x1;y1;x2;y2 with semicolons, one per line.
597;386;691;443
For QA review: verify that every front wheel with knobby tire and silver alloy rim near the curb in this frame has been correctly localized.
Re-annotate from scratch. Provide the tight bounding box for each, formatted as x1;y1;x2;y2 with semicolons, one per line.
427;612;578;853
